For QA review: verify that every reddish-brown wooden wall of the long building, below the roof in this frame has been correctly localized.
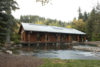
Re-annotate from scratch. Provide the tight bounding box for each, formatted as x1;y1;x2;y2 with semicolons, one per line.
21;30;86;43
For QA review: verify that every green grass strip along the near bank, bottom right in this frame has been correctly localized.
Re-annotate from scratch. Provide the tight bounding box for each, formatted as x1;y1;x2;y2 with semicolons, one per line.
41;59;100;67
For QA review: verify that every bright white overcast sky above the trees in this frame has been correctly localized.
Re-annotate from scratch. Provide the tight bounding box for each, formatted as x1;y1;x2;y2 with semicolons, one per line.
12;0;100;22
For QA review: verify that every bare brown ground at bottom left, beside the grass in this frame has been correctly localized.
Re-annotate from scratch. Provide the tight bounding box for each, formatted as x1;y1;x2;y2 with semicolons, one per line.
0;53;43;67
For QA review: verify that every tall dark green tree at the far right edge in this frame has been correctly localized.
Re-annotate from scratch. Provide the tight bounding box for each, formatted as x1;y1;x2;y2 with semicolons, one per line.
86;5;100;40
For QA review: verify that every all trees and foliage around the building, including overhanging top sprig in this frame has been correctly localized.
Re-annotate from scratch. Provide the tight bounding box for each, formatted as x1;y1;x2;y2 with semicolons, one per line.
0;0;100;44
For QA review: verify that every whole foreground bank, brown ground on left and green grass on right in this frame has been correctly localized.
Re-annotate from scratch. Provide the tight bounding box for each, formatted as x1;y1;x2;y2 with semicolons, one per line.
0;53;100;67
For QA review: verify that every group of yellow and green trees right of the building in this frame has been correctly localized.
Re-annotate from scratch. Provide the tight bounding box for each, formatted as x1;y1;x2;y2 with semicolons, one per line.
70;3;100;41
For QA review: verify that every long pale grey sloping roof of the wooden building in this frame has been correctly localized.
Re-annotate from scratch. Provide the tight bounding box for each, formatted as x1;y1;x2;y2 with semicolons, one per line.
21;23;86;35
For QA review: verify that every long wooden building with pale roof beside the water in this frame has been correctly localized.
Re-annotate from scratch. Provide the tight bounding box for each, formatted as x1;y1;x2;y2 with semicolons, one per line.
19;23;86;43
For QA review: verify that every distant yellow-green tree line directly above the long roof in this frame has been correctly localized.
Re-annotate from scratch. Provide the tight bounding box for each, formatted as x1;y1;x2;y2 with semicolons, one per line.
20;15;67;27
